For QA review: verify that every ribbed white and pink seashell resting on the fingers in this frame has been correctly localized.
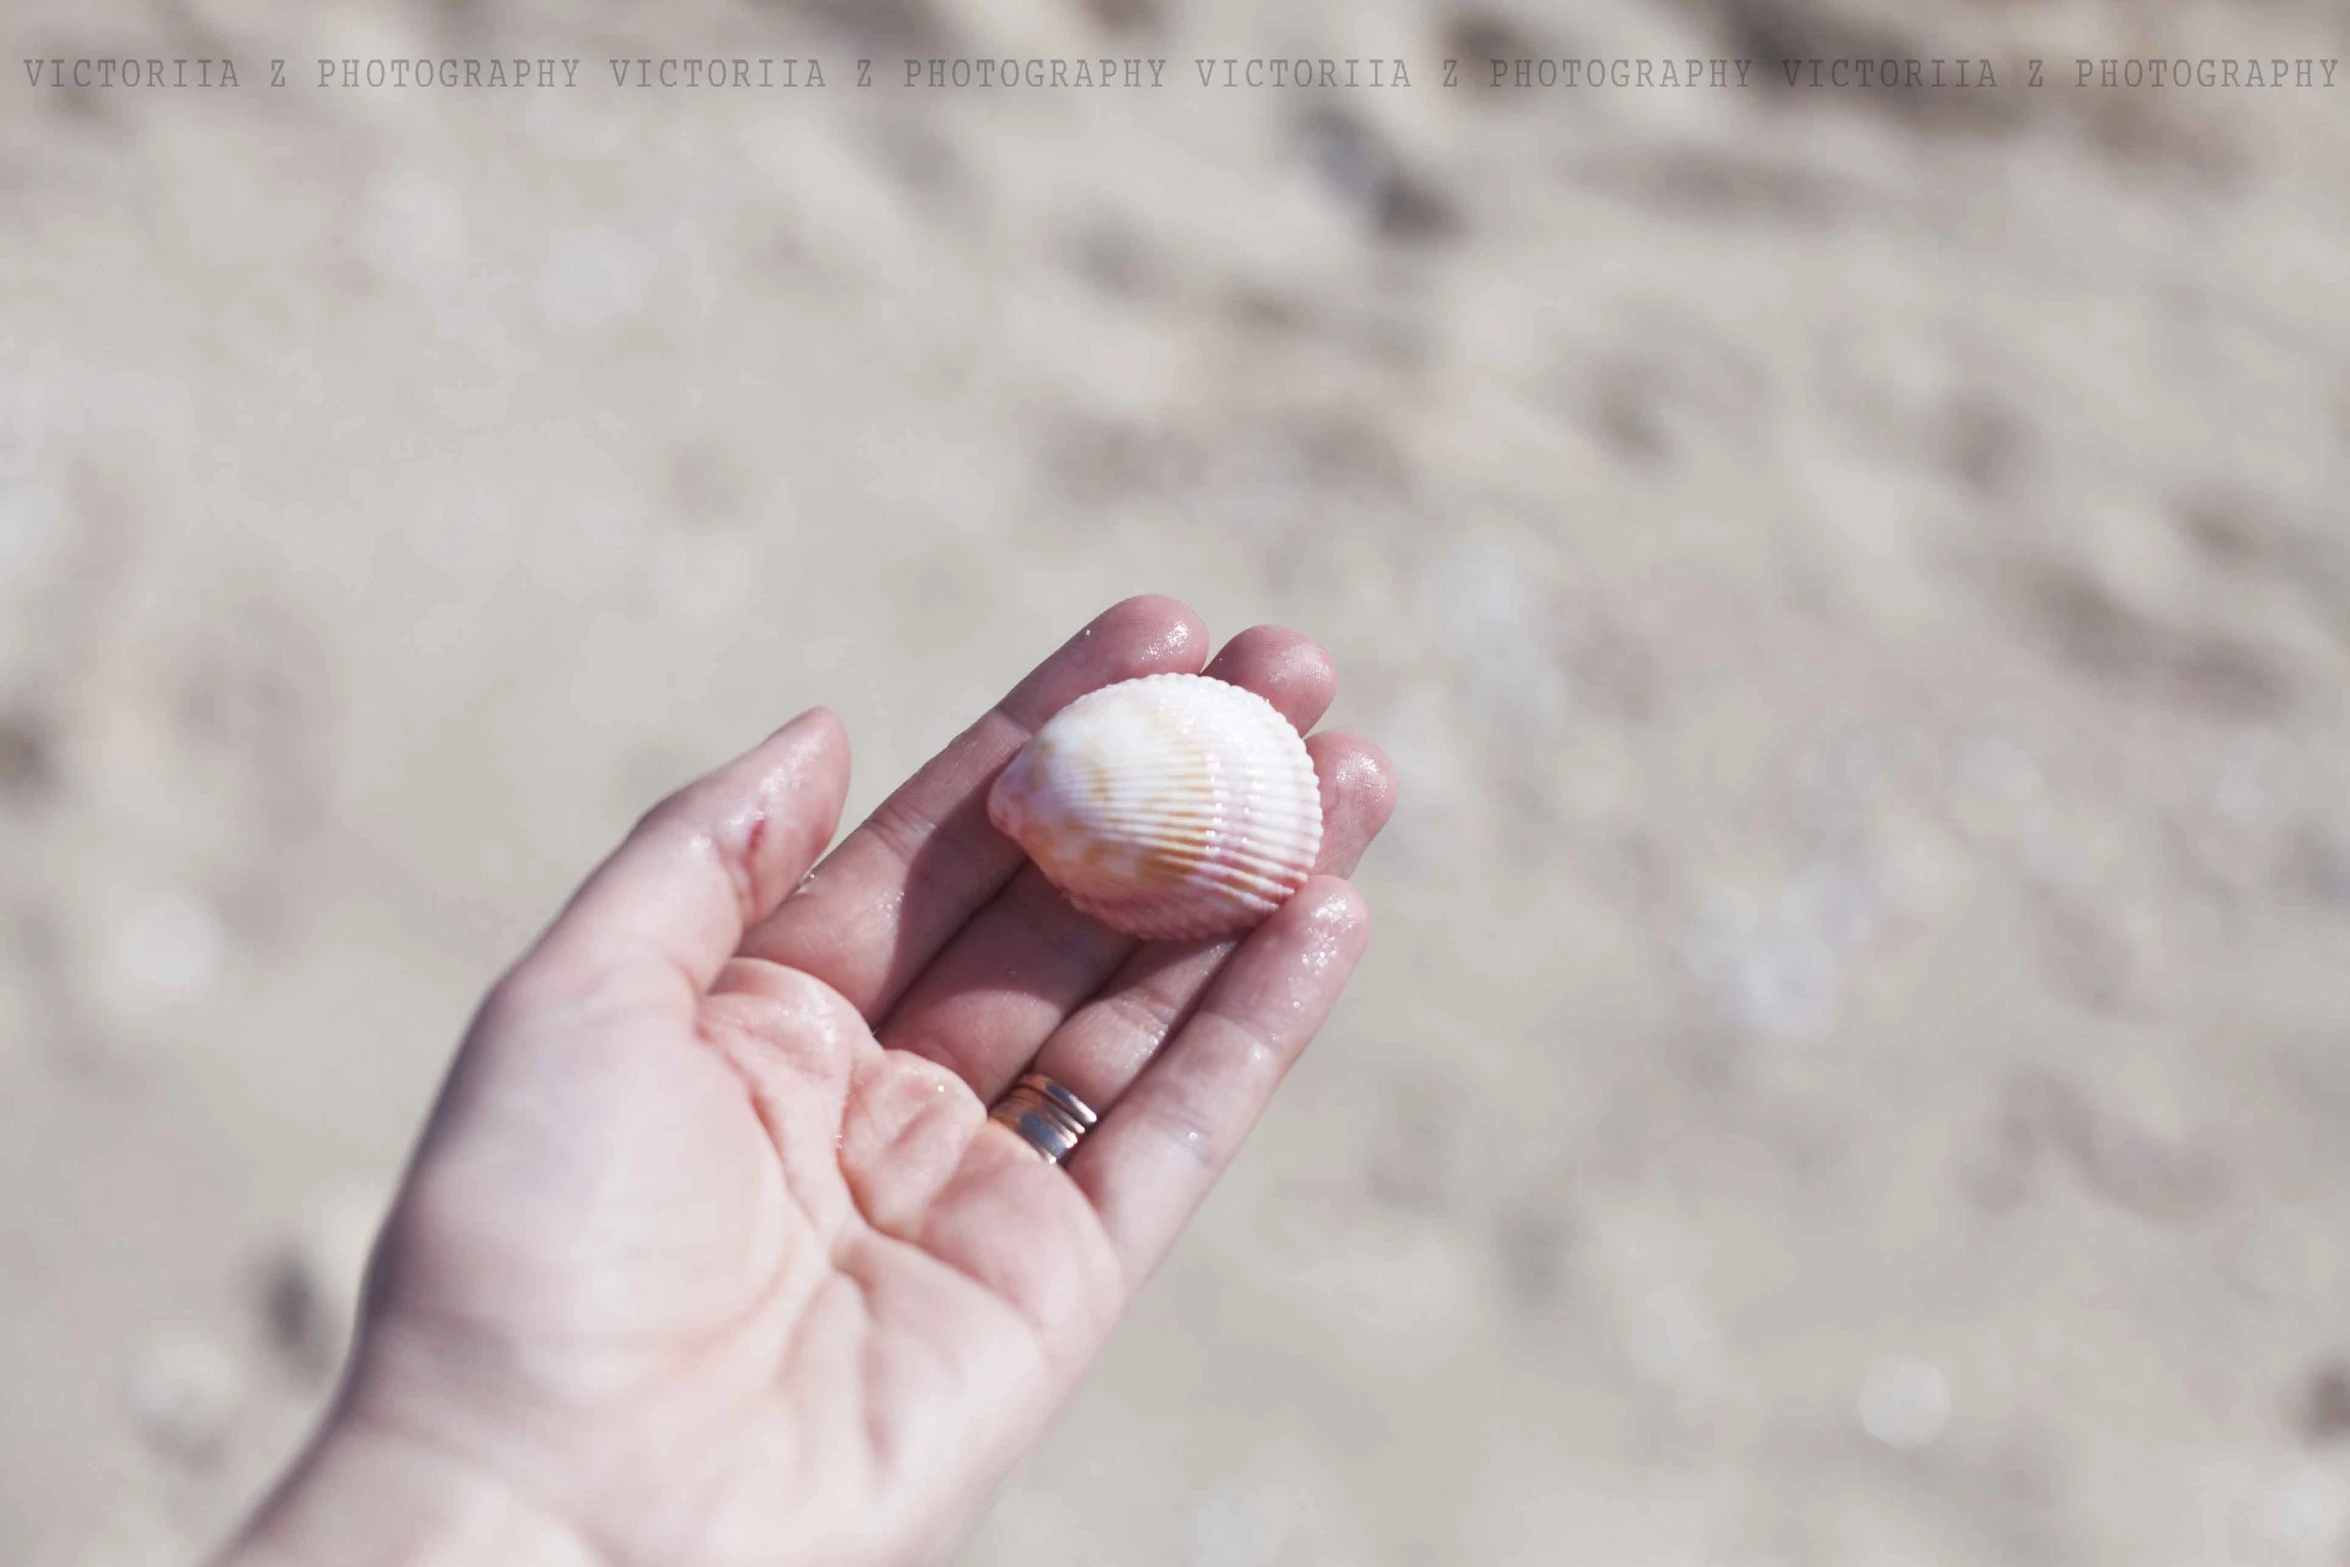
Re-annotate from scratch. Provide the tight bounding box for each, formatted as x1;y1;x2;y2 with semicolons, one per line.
987;674;1321;942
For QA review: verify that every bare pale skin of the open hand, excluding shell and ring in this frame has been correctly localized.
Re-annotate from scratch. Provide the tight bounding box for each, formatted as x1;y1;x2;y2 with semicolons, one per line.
221;599;1394;1567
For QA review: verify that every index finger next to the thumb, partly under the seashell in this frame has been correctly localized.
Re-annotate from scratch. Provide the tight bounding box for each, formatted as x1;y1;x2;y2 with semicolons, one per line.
743;597;1208;1024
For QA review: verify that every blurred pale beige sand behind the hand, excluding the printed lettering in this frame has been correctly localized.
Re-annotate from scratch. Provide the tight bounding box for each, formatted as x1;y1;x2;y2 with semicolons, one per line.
0;0;2350;1567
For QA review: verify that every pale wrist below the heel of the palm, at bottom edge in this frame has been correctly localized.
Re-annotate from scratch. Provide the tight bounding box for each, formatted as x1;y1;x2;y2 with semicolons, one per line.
216;1419;609;1567
